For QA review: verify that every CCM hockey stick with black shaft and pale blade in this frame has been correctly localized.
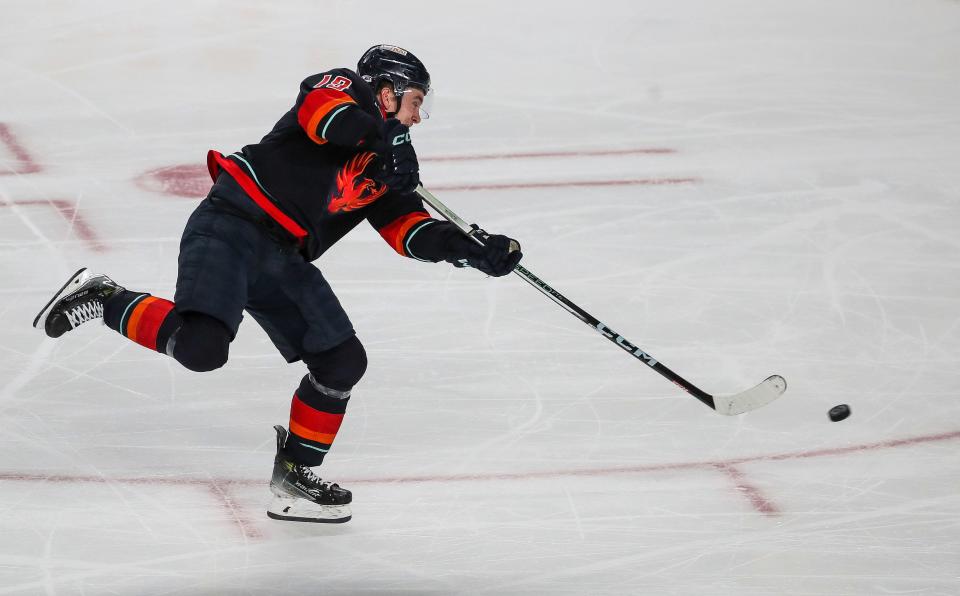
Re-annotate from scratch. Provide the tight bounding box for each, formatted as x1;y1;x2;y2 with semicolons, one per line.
417;186;787;416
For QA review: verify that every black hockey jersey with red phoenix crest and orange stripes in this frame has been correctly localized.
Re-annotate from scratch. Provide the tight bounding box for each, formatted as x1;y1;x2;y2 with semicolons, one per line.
208;68;437;261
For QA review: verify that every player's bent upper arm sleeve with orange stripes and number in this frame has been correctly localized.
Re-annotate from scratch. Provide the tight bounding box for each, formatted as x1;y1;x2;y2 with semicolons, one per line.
295;68;383;147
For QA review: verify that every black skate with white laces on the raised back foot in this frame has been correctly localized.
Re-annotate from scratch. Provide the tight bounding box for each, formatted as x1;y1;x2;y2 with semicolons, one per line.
33;267;123;337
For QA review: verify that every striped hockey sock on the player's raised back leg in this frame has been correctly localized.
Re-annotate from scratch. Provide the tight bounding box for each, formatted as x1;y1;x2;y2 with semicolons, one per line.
103;290;182;354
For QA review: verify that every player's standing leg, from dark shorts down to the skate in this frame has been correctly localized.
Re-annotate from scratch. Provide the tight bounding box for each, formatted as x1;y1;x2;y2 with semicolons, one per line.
248;255;367;522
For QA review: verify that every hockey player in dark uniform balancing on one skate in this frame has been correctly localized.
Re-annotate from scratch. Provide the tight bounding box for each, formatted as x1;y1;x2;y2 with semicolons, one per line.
34;45;522;522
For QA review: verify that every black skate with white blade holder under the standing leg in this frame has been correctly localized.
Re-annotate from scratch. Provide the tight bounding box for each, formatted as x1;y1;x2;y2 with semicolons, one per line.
267;425;353;524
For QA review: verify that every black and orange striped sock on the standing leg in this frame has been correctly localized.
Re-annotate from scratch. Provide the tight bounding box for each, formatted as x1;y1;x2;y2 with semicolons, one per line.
286;375;350;466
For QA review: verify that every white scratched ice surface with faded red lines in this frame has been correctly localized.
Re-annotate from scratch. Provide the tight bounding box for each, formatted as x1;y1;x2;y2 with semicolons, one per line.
0;0;960;596
